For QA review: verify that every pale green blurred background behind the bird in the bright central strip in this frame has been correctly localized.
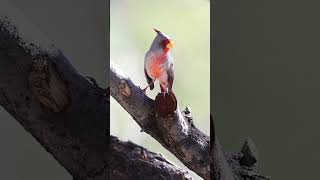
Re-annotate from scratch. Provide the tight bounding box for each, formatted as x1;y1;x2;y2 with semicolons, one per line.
110;0;210;179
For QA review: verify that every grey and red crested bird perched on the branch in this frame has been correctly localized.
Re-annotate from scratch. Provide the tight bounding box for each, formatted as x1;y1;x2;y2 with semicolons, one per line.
143;28;174;97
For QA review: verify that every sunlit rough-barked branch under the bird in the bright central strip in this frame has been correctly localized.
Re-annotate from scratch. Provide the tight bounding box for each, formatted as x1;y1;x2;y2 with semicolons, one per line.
110;65;210;179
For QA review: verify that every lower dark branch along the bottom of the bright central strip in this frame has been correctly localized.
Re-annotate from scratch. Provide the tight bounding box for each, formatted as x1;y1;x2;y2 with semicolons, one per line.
110;136;191;180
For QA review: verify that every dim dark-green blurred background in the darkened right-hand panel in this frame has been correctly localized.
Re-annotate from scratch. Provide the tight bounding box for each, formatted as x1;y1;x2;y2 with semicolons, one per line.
211;0;320;180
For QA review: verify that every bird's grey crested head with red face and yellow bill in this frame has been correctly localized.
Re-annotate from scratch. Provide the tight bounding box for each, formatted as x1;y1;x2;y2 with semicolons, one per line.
151;28;173;53
